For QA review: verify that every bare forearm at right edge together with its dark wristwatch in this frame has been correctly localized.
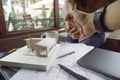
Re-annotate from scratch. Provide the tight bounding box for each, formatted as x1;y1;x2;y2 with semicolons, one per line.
93;0;120;33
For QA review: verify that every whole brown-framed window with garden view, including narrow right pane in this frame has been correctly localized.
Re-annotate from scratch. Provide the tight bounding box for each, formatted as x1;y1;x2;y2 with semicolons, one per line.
0;0;65;37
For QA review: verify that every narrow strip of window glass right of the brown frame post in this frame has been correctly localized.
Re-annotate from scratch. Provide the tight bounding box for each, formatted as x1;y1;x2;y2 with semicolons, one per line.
59;0;65;27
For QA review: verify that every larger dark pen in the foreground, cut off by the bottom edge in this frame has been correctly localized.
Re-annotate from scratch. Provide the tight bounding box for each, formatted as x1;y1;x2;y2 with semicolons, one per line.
58;64;89;80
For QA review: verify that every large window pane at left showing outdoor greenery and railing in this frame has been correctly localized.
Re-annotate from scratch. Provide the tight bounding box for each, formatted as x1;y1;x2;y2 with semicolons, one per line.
2;0;54;32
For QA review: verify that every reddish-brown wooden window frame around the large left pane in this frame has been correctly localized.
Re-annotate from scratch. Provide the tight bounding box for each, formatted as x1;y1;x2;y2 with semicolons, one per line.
0;0;60;39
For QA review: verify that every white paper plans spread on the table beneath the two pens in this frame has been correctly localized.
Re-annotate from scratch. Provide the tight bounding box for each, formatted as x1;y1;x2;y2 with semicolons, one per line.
10;43;109;80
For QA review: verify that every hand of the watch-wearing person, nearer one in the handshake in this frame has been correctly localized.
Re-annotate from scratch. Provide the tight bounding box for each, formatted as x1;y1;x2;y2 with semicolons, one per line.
69;10;96;42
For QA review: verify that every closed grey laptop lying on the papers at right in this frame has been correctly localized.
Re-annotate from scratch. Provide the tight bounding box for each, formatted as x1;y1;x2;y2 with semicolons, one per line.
77;48;120;80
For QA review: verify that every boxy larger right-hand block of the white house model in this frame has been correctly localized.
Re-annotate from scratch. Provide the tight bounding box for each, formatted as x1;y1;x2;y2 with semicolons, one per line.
35;38;57;57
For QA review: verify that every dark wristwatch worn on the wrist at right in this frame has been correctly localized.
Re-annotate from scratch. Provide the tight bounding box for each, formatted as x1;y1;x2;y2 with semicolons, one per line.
93;6;110;33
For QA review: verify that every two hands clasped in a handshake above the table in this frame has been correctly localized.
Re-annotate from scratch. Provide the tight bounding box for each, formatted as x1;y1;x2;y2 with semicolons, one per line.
64;10;96;42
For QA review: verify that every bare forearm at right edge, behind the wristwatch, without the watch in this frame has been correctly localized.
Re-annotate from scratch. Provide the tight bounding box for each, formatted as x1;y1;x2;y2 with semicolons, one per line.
104;0;120;30
